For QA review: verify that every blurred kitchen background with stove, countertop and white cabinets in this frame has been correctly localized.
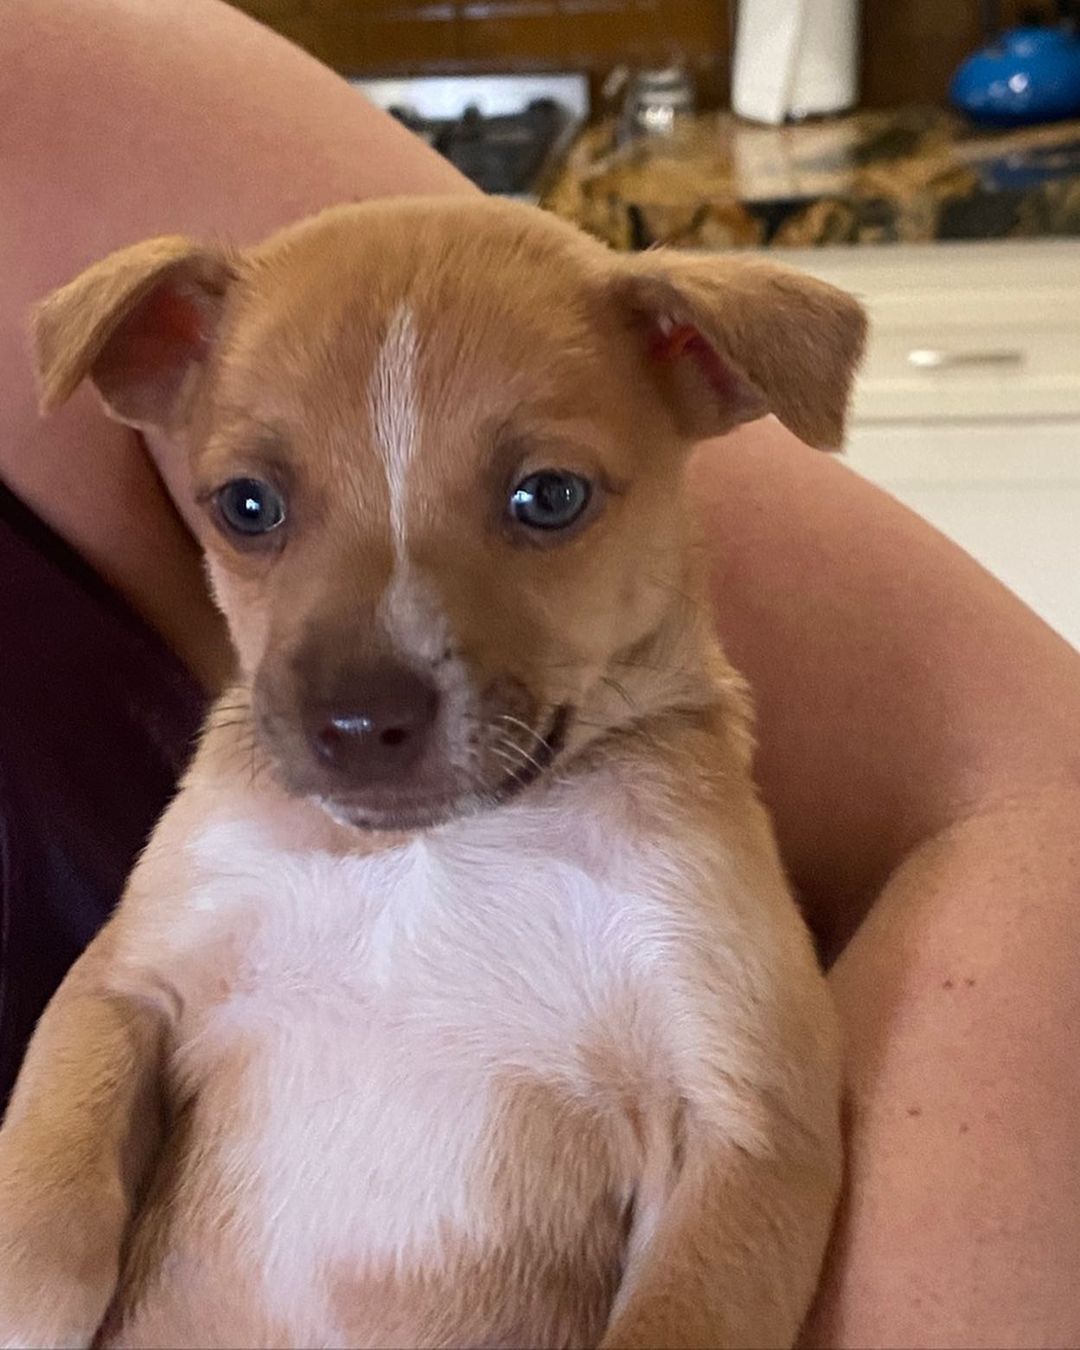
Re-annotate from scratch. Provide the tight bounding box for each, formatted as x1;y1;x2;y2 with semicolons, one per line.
229;0;1080;645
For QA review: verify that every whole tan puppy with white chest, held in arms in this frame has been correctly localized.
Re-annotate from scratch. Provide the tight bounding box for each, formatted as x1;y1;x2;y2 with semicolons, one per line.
0;201;863;1347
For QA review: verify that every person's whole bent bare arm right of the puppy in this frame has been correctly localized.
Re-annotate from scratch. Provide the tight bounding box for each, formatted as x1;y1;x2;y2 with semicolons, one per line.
695;423;1080;1347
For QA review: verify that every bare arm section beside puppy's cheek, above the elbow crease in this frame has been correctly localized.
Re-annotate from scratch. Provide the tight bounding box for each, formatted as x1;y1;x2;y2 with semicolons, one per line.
691;421;1080;952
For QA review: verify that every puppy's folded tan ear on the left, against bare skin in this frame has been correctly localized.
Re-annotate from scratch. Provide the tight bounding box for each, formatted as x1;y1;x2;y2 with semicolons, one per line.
32;236;236;429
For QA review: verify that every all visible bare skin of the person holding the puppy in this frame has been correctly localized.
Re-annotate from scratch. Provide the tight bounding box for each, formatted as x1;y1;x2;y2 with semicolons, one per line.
0;0;1080;1347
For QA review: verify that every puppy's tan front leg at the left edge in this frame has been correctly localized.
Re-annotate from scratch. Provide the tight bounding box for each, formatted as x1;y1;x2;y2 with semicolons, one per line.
0;929;165;1347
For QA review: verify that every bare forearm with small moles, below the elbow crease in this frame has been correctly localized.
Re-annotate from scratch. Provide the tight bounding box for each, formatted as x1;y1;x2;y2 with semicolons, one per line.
806;788;1080;1347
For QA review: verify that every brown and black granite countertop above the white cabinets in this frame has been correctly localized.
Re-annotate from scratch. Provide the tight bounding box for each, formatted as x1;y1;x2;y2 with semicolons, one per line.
544;108;1080;250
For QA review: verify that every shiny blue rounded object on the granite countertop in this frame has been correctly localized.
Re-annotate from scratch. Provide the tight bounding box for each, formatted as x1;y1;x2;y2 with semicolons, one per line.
949;27;1080;127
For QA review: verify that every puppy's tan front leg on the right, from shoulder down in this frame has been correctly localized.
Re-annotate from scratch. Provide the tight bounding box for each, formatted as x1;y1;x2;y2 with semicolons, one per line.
602;820;842;1350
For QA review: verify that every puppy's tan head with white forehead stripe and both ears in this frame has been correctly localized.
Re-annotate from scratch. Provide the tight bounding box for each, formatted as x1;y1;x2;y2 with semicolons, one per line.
35;201;863;828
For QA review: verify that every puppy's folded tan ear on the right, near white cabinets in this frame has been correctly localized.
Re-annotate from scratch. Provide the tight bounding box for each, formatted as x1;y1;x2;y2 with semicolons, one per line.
618;252;867;450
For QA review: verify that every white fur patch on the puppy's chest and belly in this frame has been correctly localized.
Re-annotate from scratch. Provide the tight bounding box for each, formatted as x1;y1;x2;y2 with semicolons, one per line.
166;788;678;1315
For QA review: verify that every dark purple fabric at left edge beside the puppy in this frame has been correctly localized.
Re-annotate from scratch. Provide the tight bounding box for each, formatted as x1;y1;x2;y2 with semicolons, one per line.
0;485;204;1114
